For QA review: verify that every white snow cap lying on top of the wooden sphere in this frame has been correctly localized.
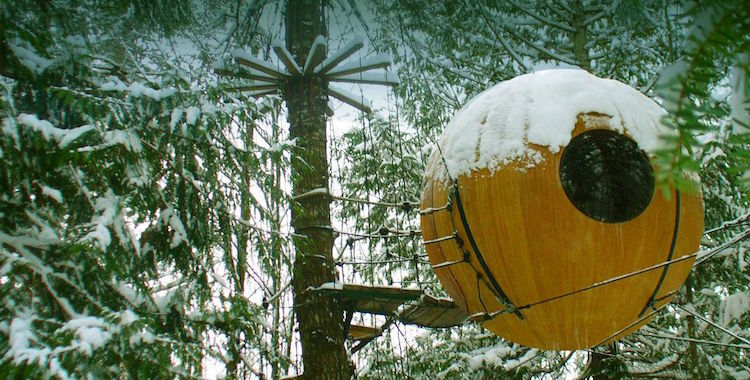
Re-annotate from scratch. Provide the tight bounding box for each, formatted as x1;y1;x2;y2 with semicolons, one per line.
432;69;668;178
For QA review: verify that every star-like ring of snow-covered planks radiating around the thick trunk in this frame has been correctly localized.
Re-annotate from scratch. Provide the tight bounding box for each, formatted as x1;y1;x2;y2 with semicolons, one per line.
214;36;399;115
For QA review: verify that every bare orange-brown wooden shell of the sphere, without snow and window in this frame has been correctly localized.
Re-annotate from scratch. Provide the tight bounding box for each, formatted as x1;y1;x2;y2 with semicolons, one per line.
421;72;703;350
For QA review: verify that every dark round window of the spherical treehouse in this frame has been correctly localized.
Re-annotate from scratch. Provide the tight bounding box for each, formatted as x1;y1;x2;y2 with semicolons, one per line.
560;129;654;223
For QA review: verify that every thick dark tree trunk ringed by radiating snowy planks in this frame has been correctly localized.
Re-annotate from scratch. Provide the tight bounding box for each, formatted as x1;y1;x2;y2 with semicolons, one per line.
284;0;354;379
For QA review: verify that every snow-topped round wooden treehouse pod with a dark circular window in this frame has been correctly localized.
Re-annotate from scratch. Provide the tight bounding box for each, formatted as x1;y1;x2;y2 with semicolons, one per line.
421;70;703;350
